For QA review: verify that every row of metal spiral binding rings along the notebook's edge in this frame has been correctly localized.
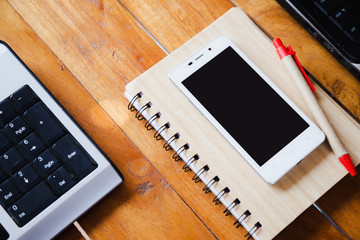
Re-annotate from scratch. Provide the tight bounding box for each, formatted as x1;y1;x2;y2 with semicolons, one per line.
128;92;262;240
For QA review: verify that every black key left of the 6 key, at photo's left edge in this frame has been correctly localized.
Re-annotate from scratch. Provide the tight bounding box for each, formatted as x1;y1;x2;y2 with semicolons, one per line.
0;148;26;176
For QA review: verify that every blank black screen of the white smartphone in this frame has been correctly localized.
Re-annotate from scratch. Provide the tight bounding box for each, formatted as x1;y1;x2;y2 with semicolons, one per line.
182;47;309;166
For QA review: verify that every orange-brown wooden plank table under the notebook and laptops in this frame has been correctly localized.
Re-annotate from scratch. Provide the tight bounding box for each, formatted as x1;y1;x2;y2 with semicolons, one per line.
0;0;360;239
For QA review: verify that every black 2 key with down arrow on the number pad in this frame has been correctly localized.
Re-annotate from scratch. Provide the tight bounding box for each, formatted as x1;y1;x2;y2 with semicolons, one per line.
13;164;40;193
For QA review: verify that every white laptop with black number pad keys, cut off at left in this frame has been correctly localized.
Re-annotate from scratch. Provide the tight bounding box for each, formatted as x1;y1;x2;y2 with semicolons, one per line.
0;41;123;240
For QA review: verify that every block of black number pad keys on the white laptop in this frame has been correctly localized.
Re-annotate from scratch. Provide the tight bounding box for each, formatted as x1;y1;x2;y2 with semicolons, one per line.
0;86;97;227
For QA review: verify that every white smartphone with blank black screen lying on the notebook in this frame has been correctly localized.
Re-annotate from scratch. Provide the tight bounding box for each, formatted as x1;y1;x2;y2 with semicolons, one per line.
169;36;325;184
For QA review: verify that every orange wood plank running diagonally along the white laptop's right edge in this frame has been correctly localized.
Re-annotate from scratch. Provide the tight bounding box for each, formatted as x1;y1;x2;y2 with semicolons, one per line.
0;1;214;239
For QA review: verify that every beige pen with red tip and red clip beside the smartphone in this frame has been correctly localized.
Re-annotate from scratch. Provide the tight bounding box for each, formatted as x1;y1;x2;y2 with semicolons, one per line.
273;38;356;176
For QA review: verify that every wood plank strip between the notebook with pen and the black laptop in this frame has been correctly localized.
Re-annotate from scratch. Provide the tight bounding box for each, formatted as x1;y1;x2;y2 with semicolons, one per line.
234;0;360;123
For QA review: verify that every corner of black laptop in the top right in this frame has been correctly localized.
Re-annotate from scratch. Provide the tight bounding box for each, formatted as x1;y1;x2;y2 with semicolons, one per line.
277;0;360;79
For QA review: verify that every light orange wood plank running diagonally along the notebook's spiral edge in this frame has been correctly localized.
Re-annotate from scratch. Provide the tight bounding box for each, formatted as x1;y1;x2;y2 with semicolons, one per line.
10;0;250;239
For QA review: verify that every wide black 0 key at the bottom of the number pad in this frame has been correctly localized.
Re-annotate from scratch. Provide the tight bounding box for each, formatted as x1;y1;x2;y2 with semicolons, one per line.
8;182;56;227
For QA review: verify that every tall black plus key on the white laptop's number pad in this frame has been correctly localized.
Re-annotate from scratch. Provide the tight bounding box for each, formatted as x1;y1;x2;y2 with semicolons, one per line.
24;103;65;145
